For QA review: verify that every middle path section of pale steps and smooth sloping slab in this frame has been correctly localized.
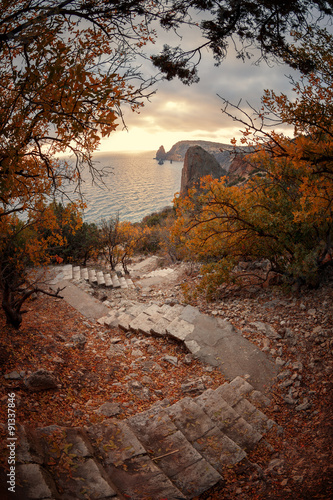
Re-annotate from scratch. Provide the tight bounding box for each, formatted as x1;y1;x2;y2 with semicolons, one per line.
98;301;278;390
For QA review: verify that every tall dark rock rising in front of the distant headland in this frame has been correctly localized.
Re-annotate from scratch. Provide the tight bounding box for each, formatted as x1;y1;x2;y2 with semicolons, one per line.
180;146;226;195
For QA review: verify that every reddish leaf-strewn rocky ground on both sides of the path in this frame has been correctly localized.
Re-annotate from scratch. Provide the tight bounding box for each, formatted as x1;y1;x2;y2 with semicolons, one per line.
0;258;333;500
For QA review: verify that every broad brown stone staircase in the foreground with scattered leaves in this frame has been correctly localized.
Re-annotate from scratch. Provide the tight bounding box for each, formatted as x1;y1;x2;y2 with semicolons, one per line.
17;377;281;500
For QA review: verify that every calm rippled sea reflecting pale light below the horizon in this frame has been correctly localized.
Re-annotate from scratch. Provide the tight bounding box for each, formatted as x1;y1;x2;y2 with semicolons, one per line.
78;151;183;224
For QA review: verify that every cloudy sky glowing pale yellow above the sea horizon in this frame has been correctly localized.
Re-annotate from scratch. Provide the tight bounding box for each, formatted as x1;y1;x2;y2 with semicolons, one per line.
99;17;292;152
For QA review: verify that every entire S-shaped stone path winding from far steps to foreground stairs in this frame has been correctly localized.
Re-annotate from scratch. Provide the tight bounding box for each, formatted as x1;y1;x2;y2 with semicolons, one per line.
31;266;277;500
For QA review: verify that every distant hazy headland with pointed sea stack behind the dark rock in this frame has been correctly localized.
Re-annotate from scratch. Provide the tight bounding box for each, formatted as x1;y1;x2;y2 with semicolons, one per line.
156;141;246;172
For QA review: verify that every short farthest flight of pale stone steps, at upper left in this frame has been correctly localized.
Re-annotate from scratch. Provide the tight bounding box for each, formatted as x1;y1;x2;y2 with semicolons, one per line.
62;264;135;289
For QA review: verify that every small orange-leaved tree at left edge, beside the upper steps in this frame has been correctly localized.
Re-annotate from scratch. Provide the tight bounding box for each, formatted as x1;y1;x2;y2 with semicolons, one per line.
0;204;80;328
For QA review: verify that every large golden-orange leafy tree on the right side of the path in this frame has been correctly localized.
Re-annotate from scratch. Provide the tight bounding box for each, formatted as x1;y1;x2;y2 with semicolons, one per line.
172;30;333;296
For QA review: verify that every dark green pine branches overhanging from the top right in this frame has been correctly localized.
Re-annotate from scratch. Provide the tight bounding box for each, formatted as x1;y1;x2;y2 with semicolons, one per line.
152;0;333;83
